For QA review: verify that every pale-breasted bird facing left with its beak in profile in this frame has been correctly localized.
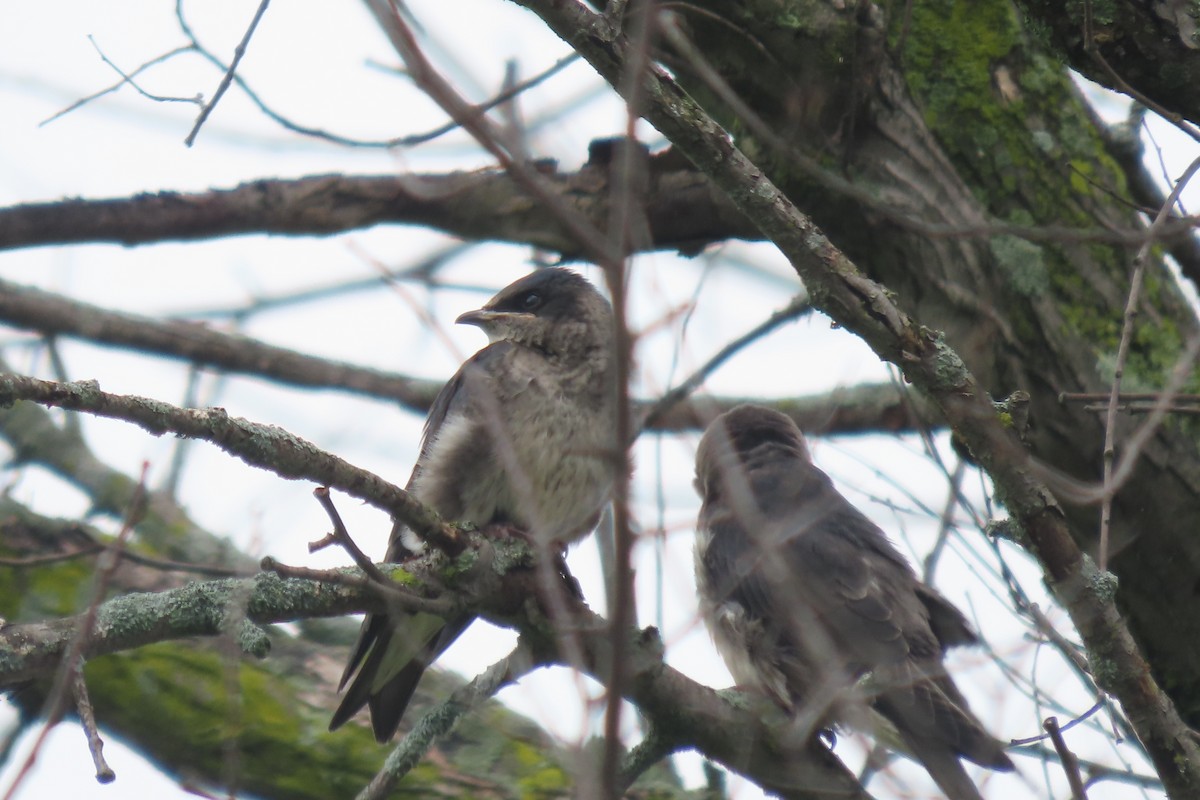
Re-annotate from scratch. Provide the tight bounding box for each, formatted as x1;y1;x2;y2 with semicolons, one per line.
329;267;623;744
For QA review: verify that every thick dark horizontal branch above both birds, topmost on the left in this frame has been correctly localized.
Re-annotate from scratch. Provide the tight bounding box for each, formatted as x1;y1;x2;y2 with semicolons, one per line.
0;166;757;257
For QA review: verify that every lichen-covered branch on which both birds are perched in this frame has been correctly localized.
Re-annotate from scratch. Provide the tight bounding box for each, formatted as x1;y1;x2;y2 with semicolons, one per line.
0;534;869;800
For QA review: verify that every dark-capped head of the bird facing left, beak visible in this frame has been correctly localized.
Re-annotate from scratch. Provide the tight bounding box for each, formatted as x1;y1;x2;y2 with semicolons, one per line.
455;267;612;355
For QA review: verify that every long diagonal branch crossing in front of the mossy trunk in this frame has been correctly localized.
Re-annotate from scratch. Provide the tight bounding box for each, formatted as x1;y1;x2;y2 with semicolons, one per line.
522;0;1200;798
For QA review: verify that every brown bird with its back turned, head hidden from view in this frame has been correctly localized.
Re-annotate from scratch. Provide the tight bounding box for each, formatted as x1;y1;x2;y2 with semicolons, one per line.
695;405;1014;800
